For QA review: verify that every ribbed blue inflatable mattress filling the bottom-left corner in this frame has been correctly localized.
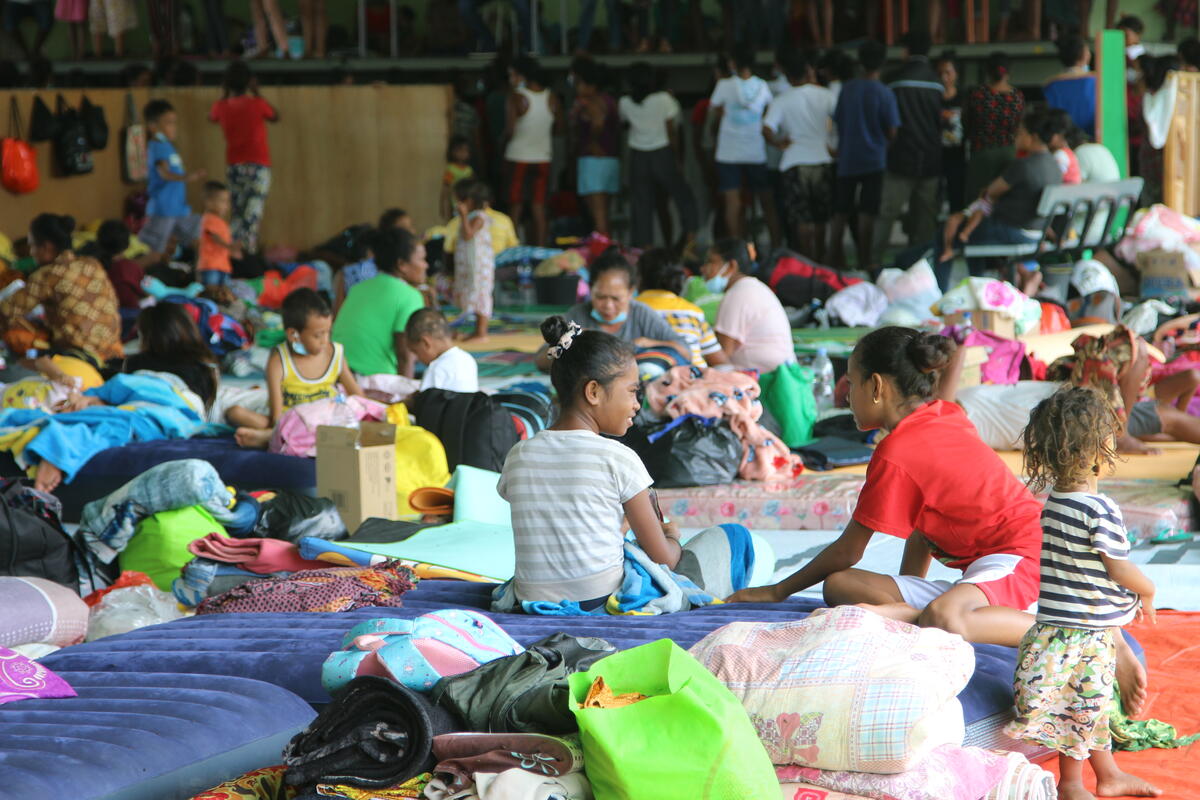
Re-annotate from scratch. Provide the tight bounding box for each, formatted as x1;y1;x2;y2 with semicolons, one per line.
0;670;316;800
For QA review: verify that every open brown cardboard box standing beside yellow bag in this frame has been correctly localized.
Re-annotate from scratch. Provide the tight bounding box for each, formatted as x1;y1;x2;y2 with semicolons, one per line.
317;422;396;534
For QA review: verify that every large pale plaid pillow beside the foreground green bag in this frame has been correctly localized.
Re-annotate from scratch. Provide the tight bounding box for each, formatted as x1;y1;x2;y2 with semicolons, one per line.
691;607;974;774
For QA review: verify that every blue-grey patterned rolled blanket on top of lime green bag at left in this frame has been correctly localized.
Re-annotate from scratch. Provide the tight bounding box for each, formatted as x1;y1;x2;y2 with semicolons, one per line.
79;458;235;564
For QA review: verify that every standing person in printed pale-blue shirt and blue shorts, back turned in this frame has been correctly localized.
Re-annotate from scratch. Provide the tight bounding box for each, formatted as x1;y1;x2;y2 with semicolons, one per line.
710;48;780;247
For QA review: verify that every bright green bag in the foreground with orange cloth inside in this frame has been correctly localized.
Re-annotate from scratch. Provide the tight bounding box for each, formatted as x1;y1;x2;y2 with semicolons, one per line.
568;639;779;800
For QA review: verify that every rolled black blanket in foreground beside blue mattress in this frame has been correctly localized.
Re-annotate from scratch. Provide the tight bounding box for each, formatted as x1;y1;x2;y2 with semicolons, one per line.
283;675;462;788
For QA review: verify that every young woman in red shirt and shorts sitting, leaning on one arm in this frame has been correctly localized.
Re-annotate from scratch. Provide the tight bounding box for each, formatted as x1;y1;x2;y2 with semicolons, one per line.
730;327;1146;714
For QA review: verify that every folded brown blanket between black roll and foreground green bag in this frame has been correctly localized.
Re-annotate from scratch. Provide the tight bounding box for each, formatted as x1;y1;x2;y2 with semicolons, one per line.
433;733;583;793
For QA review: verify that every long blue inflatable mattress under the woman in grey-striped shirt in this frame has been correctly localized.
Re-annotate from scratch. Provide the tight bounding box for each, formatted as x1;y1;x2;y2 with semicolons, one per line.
42;581;1104;747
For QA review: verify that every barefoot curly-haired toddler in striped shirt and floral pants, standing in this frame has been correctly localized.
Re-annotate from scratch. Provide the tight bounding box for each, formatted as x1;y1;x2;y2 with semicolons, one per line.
1004;387;1162;800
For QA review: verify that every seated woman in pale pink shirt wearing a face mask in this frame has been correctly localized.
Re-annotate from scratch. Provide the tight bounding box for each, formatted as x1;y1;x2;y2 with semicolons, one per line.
701;239;796;373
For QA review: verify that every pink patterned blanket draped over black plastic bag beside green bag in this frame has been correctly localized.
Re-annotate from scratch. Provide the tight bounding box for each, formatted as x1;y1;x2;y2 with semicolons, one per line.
646;367;804;481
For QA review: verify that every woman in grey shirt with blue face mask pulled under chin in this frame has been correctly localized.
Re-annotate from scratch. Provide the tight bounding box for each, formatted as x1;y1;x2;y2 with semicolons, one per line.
536;247;691;372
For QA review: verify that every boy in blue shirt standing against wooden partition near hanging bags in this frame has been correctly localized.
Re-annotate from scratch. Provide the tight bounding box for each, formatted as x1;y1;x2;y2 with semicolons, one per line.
138;100;205;257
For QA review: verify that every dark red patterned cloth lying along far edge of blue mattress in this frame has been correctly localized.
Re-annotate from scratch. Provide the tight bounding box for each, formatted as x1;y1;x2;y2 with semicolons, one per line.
196;561;415;614
